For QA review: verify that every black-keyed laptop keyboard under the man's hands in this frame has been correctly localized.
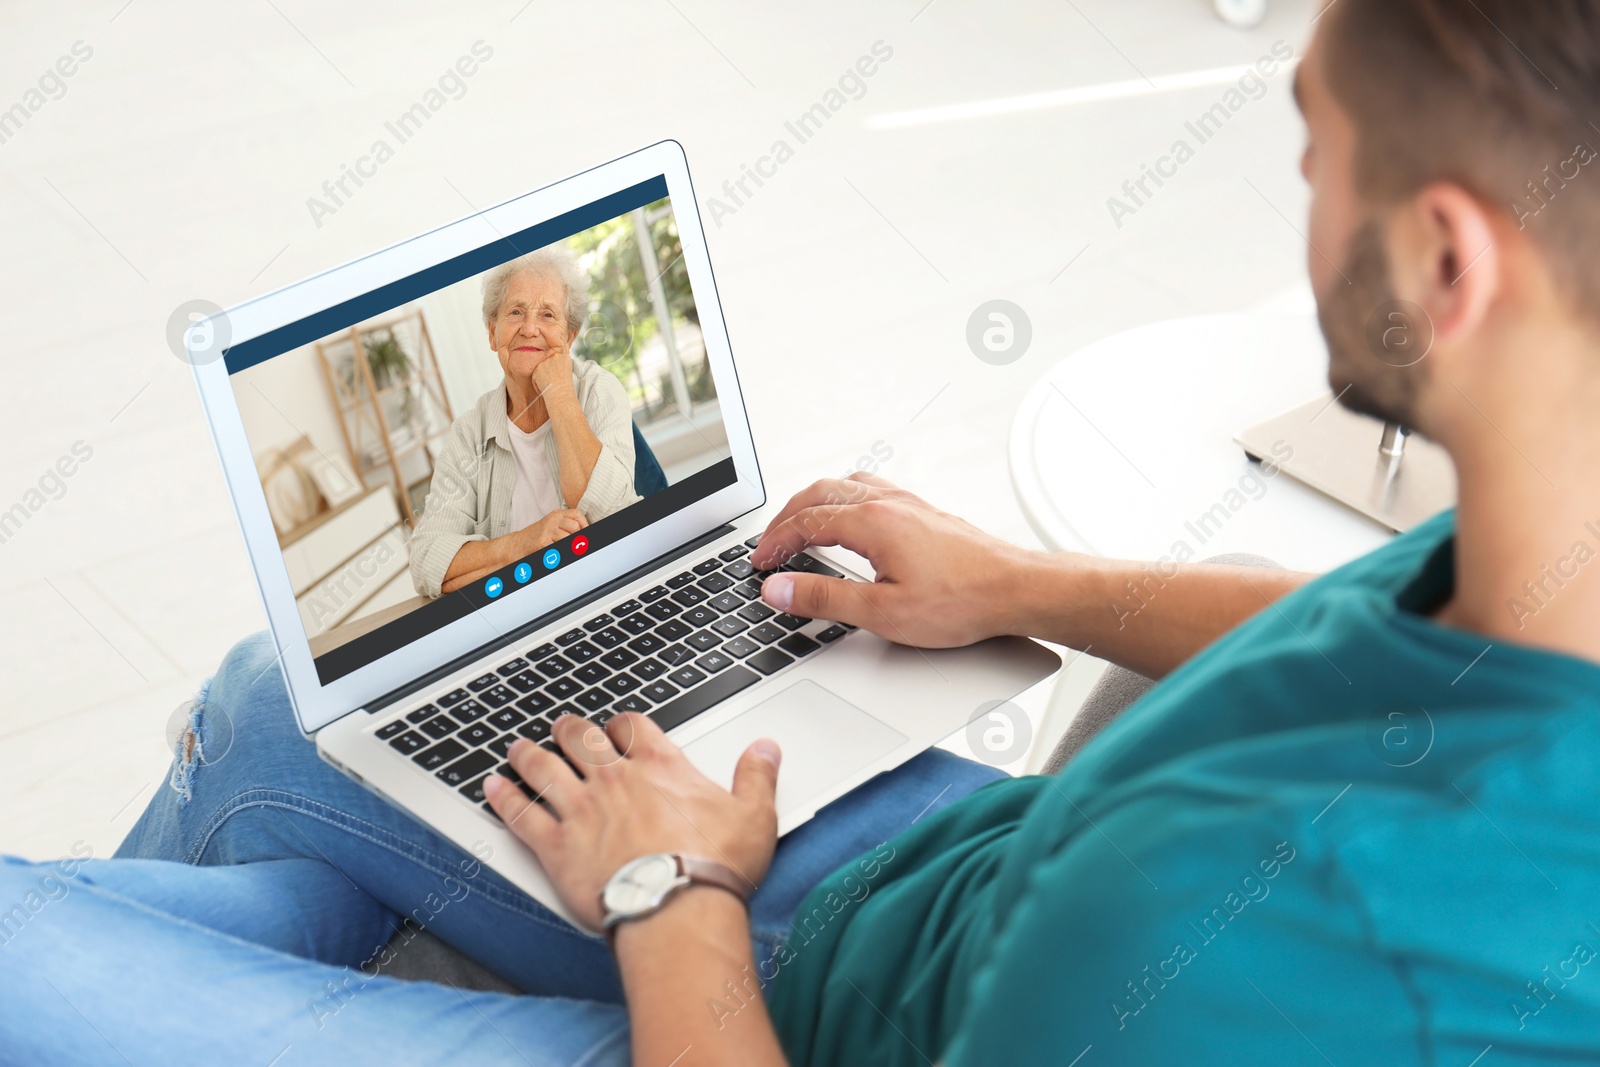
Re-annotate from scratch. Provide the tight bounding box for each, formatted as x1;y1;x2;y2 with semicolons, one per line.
374;537;854;814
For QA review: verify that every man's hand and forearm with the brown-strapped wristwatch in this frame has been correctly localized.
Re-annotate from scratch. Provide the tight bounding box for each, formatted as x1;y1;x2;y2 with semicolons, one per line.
483;712;784;1067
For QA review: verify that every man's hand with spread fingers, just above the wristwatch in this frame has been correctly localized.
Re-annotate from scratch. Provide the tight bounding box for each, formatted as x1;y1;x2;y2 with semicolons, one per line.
483;713;779;929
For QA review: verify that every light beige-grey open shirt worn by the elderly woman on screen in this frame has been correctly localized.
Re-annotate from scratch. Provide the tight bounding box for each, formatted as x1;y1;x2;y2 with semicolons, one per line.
411;357;640;597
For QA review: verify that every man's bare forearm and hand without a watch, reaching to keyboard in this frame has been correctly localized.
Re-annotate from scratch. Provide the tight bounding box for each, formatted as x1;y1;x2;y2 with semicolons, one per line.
750;474;1312;678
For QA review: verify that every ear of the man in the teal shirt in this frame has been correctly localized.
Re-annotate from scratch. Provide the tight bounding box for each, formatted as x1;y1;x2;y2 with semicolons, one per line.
1389;182;1506;341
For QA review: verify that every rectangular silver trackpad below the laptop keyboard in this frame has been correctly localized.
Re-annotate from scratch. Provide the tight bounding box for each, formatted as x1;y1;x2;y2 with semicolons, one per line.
685;678;909;819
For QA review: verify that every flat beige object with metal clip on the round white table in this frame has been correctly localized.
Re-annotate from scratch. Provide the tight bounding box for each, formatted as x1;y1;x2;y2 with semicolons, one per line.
1234;394;1456;533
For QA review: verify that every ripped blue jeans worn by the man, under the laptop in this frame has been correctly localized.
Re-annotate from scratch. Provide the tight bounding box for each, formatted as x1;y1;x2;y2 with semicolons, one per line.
0;635;1000;1067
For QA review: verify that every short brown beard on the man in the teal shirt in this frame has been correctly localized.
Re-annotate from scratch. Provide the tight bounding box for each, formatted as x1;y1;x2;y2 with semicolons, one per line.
1317;221;1434;427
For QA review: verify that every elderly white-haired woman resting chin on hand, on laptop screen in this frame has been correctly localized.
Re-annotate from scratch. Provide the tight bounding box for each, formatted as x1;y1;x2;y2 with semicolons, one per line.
411;245;640;597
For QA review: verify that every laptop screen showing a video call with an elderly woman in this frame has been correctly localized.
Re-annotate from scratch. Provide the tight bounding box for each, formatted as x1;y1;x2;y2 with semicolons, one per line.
224;176;738;685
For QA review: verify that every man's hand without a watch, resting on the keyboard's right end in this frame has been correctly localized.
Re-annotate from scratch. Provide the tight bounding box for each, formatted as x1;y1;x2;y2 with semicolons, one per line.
750;472;1029;648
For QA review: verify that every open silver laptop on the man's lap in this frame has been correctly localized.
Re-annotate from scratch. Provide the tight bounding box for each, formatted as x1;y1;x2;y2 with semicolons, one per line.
184;141;1059;920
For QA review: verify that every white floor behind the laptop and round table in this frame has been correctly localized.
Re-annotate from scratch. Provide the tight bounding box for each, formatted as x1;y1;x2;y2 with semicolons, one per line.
0;0;1312;857
